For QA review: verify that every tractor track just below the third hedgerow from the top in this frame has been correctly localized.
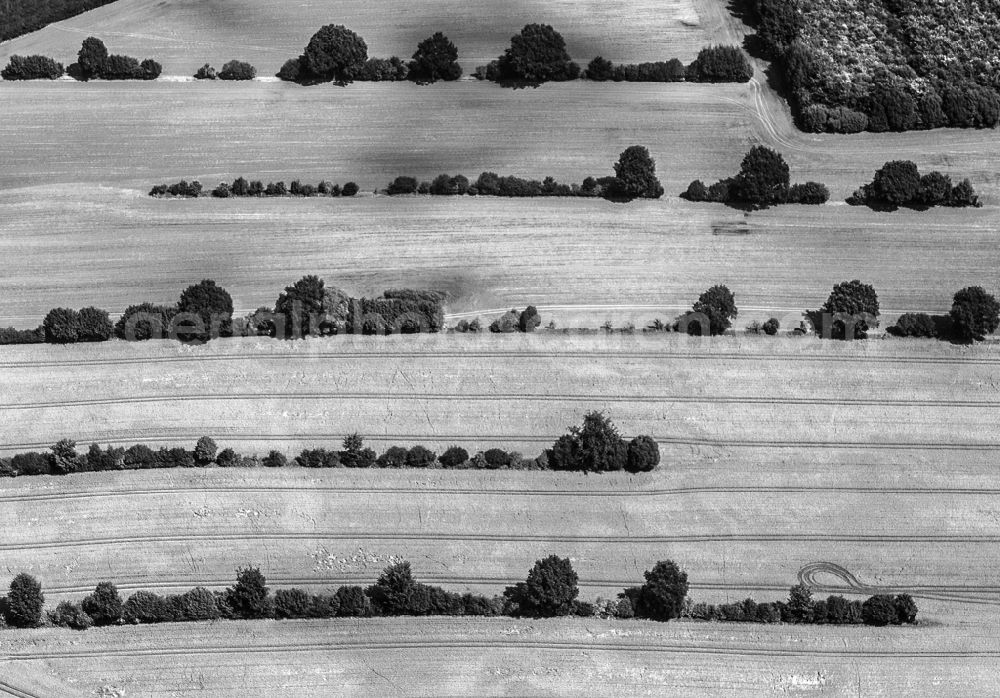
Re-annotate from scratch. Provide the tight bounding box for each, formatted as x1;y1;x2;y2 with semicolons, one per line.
0;350;1000;369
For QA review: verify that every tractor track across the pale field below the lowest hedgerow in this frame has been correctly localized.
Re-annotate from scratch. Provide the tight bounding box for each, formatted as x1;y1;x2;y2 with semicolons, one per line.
2;638;1000;661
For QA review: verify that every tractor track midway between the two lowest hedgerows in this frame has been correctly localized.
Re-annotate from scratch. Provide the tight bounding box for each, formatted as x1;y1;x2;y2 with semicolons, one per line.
0;531;1000;552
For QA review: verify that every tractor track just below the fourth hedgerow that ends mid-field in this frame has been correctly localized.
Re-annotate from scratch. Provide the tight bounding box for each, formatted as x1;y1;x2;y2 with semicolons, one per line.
0;485;1000;503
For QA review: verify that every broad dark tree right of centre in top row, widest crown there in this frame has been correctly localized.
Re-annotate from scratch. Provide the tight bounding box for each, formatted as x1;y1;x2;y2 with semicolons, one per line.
497;24;580;83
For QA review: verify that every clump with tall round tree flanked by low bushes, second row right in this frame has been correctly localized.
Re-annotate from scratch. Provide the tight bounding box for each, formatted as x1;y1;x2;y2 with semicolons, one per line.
681;145;830;210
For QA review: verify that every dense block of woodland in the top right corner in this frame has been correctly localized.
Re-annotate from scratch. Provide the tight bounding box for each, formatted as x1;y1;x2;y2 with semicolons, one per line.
745;0;1000;133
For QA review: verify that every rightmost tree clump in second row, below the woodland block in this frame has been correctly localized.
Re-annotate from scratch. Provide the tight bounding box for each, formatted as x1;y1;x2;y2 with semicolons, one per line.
847;160;982;211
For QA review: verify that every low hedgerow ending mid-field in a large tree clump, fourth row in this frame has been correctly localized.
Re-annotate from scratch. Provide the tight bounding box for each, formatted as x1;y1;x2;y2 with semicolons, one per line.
0;412;660;477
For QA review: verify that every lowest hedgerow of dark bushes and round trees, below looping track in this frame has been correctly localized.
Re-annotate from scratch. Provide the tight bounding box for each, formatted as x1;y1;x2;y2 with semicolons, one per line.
0;555;918;630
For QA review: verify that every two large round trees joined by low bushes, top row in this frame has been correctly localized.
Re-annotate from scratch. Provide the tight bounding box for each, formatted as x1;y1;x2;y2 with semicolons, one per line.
278;24;462;85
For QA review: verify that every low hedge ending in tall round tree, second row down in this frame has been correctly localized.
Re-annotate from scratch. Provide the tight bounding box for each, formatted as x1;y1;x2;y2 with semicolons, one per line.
385;145;663;201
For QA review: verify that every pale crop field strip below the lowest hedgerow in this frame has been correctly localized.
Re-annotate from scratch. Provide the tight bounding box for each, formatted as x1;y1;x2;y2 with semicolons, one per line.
4;618;1000;697
